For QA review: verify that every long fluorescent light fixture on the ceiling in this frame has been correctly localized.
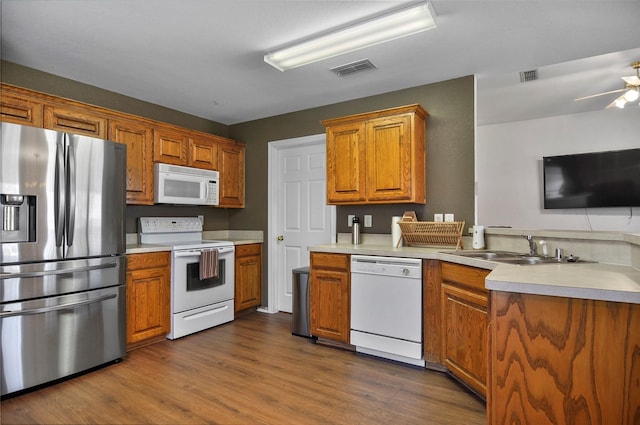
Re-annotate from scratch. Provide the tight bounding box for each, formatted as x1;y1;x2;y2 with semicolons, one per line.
264;2;436;71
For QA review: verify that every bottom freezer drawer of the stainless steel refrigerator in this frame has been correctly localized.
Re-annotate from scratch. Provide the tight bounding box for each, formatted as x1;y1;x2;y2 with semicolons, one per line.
0;285;126;395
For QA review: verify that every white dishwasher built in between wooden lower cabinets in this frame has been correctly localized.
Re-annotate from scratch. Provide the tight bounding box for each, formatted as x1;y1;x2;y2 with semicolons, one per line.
350;255;425;366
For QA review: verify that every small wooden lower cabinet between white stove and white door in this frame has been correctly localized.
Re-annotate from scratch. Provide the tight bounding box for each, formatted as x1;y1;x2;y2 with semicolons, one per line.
234;243;262;313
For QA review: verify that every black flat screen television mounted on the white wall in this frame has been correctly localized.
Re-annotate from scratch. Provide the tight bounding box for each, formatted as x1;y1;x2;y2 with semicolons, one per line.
542;149;640;209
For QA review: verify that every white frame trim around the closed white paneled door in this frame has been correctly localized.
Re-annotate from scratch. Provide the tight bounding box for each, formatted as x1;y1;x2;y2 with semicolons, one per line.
260;133;337;313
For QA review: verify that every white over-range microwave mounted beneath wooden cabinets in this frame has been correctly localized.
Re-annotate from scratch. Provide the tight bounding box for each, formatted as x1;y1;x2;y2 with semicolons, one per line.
153;162;220;205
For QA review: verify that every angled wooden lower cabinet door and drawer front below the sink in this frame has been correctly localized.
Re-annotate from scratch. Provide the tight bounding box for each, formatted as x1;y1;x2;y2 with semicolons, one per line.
440;262;489;396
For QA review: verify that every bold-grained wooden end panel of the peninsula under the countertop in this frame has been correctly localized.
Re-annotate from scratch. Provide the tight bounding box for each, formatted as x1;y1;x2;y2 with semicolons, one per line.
487;291;640;425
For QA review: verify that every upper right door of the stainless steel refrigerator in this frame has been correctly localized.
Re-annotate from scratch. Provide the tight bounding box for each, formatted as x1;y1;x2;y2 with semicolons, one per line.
65;135;127;258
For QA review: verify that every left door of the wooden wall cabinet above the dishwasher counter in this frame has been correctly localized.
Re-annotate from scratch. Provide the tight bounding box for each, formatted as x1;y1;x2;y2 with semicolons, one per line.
327;122;366;203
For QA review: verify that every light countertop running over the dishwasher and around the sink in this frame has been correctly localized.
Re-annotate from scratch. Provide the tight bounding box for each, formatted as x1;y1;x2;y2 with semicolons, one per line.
309;243;640;304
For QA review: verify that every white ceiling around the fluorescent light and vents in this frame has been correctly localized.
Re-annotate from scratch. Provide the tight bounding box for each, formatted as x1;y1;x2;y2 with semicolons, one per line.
0;0;640;124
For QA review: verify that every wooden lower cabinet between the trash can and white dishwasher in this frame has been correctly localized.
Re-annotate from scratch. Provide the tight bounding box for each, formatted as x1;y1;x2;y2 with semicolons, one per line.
309;252;351;344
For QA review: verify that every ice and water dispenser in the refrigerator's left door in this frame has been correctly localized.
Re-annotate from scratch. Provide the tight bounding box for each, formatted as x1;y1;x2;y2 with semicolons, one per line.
0;193;36;242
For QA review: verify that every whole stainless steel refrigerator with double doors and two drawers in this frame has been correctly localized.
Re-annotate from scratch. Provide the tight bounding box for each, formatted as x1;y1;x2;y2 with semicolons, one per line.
0;123;126;396
